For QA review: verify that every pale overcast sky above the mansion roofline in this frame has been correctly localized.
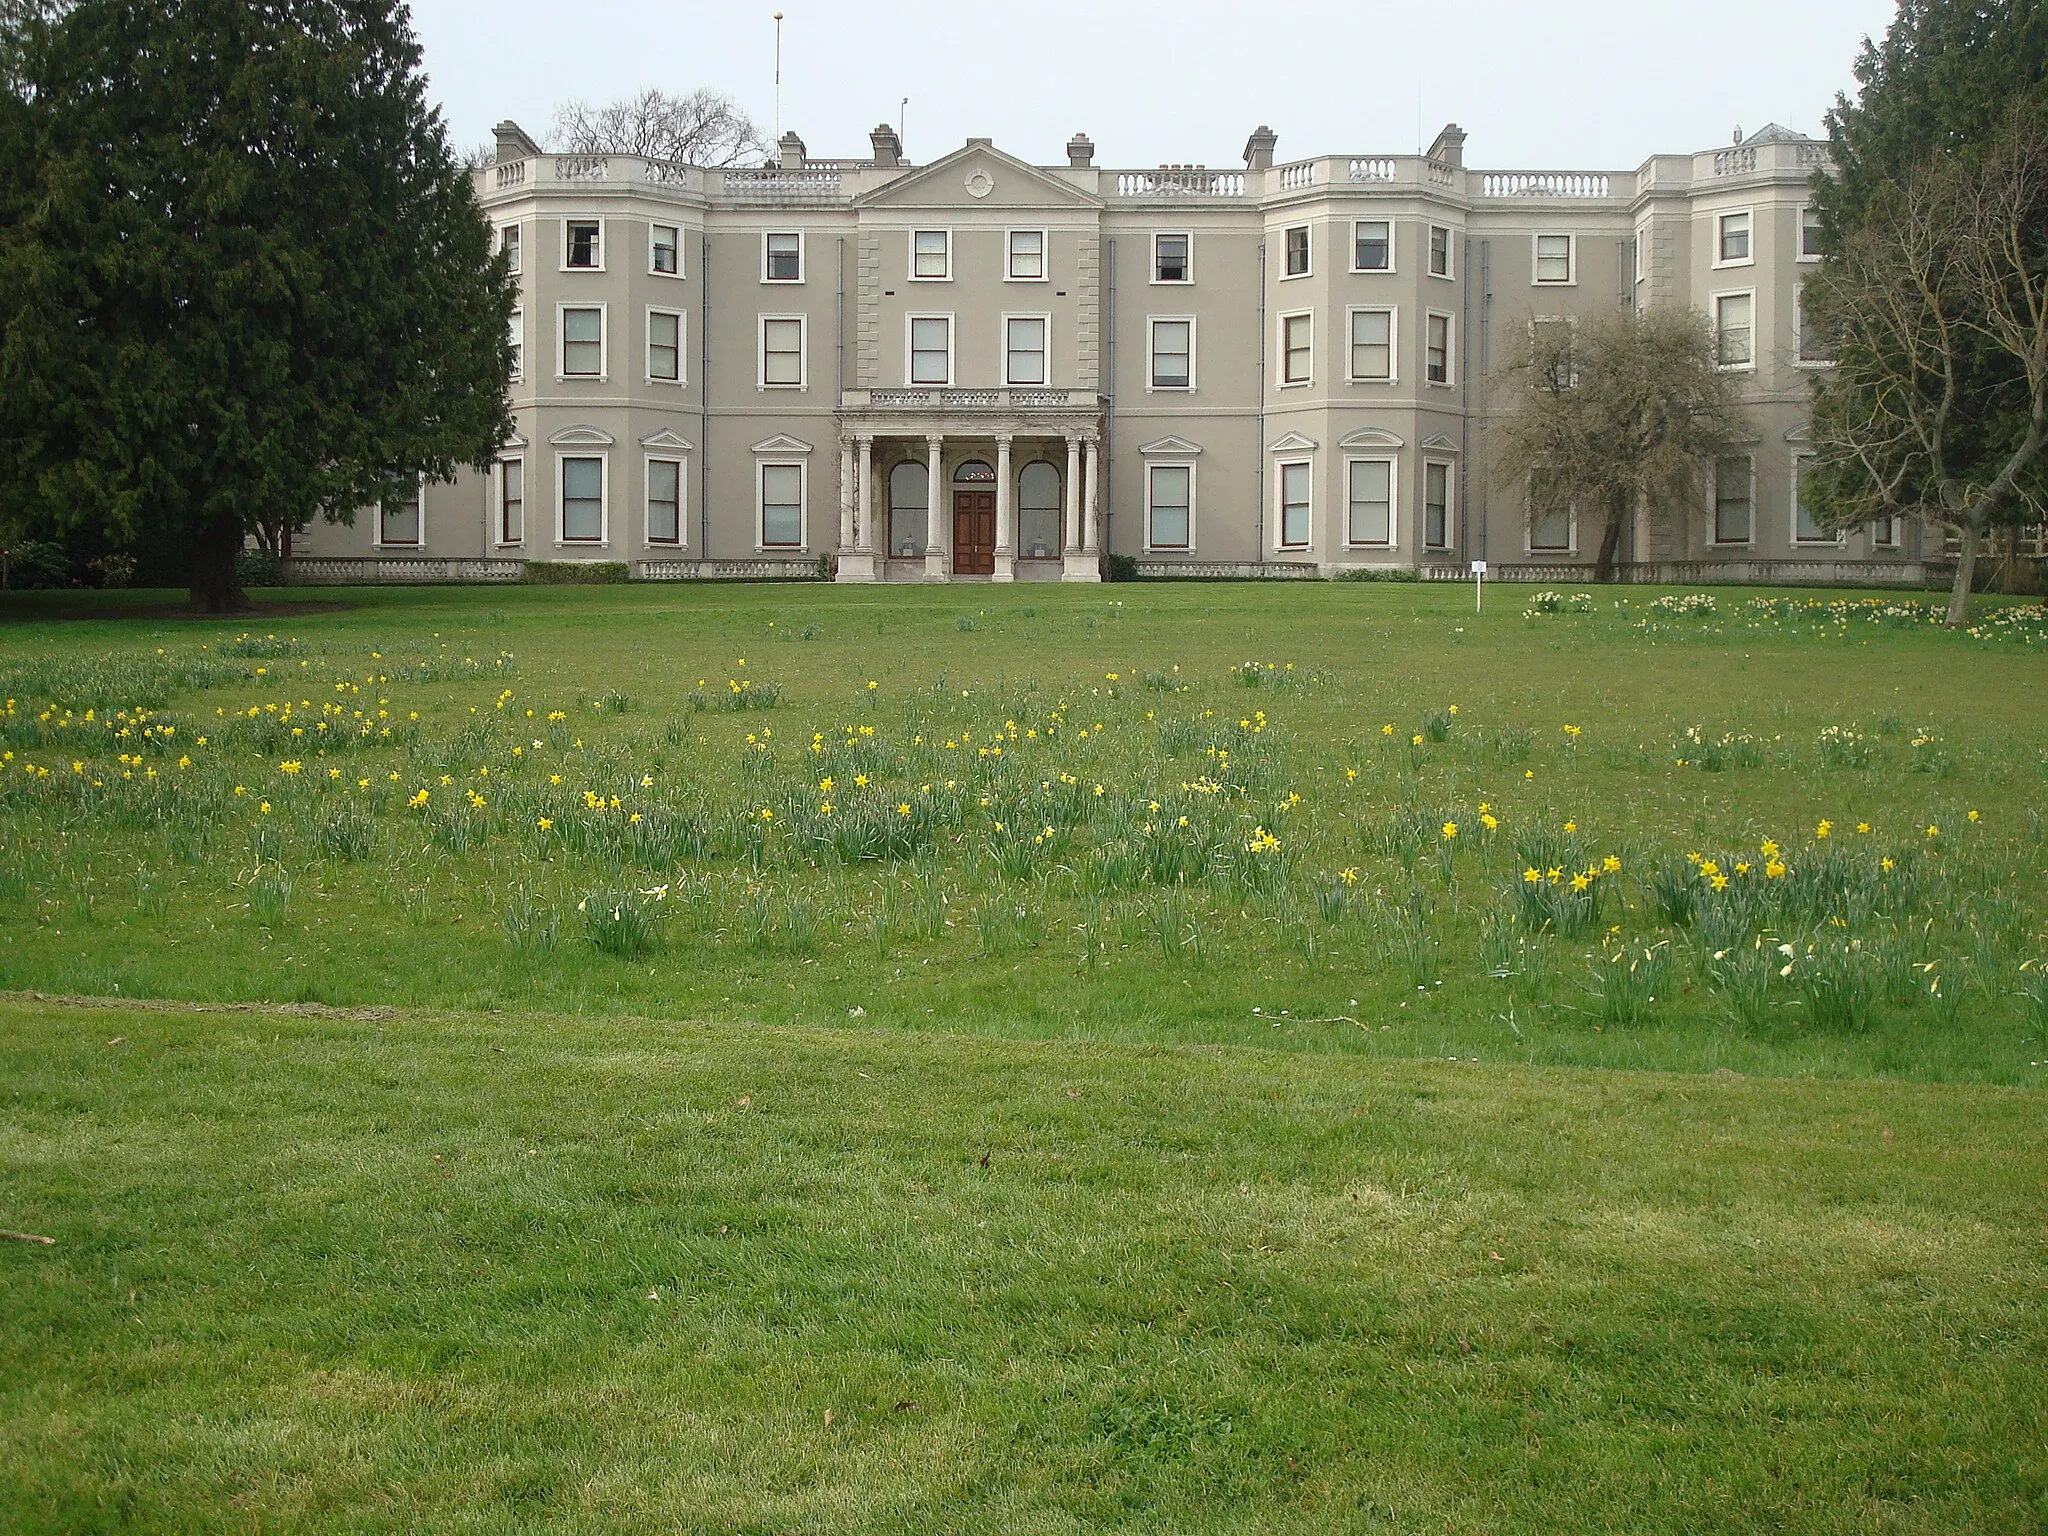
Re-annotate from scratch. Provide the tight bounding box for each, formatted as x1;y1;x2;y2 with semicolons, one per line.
414;0;1894;170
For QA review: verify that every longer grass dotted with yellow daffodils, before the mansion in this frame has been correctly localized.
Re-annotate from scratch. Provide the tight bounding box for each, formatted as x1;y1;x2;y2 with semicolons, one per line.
0;584;2048;1083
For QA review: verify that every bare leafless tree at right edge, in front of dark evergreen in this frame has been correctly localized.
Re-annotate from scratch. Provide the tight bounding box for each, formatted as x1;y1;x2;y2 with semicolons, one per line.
1804;109;2048;629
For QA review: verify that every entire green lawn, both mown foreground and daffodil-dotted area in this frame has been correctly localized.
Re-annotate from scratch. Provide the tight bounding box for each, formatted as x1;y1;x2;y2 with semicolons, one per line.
0;584;2048;1536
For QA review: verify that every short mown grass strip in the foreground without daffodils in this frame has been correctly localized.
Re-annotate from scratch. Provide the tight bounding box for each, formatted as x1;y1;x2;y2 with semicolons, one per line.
0;1001;2048;1536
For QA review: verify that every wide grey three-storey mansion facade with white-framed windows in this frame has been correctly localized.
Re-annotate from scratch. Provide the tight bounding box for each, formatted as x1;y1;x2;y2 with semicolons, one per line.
291;123;1939;582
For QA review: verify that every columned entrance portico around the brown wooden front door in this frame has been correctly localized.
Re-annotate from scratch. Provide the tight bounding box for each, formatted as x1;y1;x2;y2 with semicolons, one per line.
838;389;1102;582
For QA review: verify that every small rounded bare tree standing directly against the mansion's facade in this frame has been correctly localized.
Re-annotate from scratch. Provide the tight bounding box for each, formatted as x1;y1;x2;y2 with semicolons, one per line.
1495;309;1743;582
